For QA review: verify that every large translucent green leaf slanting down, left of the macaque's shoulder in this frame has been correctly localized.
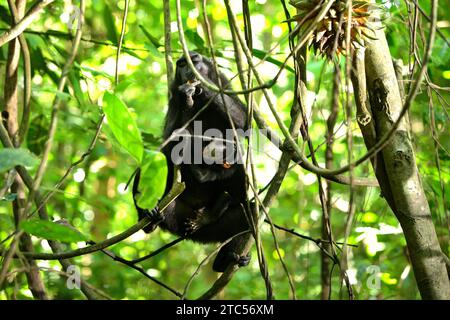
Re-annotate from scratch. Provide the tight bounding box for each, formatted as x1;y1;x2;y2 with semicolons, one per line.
103;92;144;162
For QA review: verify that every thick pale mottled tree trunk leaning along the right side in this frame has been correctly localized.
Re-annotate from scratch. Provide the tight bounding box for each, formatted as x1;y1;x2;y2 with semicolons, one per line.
365;30;450;299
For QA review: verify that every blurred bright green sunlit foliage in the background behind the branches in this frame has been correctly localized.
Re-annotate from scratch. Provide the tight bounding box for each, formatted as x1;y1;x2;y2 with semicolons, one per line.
0;0;450;299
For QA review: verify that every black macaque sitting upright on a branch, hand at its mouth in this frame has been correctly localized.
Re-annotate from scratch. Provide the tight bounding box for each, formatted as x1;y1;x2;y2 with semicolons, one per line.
133;52;250;272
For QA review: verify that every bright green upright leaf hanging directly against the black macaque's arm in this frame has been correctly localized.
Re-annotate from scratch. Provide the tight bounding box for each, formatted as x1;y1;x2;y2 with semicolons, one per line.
136;150;167;209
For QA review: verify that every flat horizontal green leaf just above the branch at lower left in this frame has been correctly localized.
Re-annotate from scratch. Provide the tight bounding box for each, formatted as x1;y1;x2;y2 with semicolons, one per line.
20;220;87;242
